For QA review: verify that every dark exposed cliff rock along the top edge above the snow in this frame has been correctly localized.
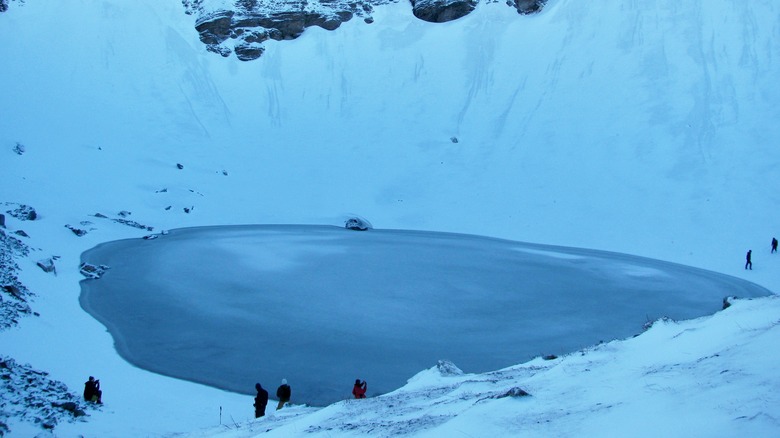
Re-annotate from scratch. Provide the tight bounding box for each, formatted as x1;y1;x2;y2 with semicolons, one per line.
185;0;547;61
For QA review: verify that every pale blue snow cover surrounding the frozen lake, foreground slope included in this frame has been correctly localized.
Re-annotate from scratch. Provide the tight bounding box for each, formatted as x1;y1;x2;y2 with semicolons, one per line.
0;0;780;436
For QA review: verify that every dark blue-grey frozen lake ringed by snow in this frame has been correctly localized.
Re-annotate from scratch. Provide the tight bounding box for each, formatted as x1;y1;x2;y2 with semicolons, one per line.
81;225;770;406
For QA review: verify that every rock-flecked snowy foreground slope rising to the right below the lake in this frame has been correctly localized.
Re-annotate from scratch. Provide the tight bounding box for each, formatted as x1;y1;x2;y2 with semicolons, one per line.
184;297;780;438
